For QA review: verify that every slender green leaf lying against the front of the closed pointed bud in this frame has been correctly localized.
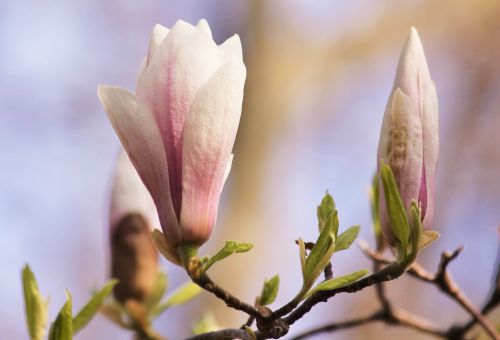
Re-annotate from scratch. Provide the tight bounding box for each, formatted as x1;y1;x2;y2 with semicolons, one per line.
380;161;410;249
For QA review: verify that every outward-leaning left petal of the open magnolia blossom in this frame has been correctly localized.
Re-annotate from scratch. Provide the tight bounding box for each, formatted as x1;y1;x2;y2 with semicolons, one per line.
97;85;181;245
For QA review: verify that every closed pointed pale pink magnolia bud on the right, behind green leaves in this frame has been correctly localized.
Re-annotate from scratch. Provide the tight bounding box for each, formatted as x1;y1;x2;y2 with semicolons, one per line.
377;28;439;243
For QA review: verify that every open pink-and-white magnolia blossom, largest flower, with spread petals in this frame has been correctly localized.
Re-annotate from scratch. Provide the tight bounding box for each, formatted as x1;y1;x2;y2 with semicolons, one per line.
98;20;246;250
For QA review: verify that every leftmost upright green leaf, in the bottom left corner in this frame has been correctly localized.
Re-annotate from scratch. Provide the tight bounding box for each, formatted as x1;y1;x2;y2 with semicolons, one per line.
22;265;48;340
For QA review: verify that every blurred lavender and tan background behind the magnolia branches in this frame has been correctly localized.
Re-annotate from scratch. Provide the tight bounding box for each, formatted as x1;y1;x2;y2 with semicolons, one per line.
0;0;500;339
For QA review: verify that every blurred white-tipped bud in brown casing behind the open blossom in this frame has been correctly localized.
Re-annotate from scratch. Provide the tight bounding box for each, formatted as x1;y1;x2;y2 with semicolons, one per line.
110;152;158;304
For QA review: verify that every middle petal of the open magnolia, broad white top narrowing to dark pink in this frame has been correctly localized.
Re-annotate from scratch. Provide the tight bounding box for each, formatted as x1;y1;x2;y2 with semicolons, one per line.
137;21;221;216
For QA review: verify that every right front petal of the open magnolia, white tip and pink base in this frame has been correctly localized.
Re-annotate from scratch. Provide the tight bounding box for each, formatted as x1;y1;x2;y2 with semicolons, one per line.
180;62;246;243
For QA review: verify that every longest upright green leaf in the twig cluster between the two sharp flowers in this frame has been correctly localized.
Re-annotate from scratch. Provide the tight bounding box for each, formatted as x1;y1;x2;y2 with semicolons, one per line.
304;211;339;286
